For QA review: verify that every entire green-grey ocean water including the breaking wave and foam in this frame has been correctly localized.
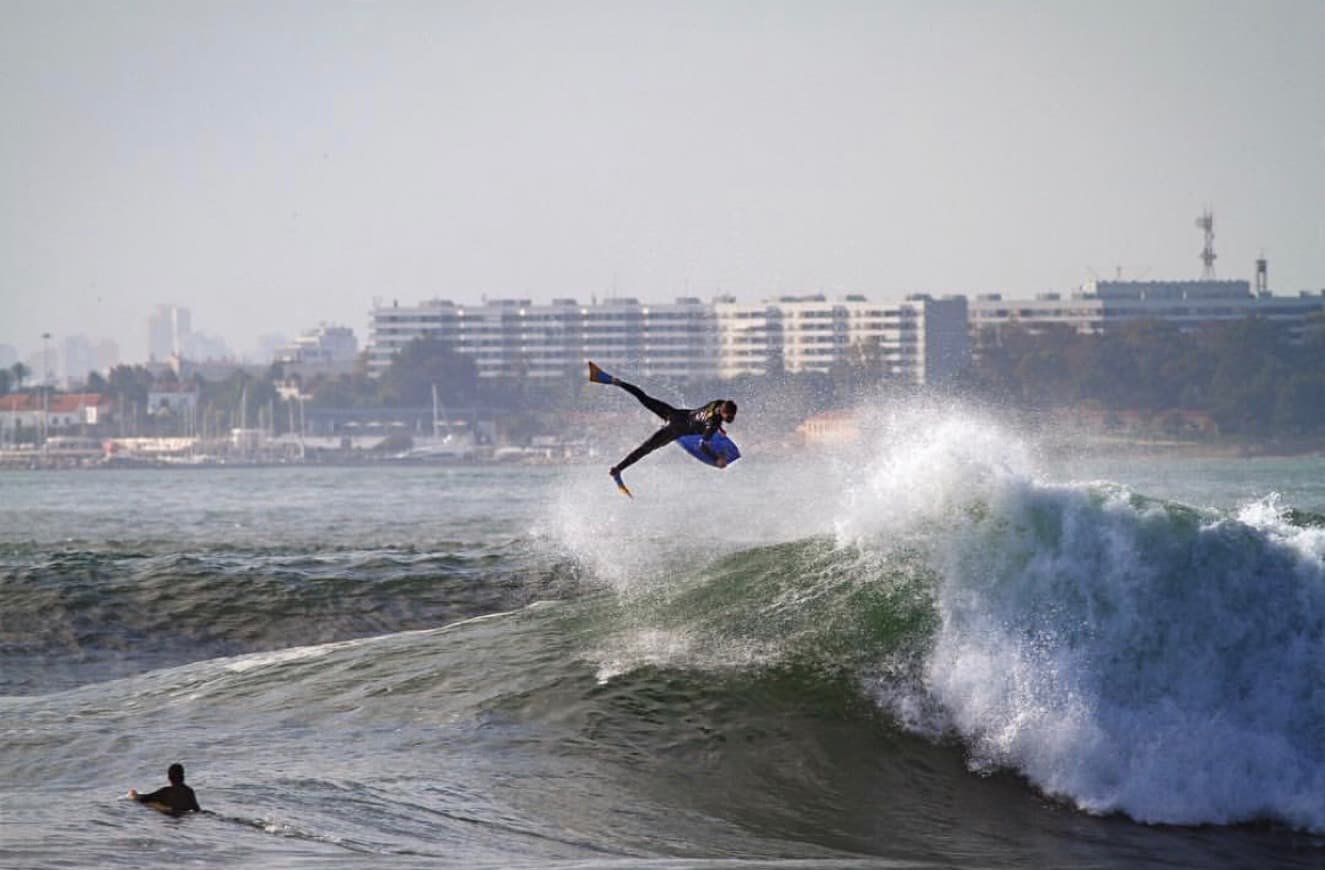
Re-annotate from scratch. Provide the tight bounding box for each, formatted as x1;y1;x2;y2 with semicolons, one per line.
0;408;1325;869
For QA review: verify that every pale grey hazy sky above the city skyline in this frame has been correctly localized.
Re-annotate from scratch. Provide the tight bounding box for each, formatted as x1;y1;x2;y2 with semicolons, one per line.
0;0;1325;362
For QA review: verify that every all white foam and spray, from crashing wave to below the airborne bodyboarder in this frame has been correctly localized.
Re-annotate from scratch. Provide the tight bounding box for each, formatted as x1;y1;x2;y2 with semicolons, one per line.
549;394;1325;832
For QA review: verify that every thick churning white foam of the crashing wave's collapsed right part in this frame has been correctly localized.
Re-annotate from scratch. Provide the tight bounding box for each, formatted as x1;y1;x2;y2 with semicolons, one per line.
839;417;1325;832
